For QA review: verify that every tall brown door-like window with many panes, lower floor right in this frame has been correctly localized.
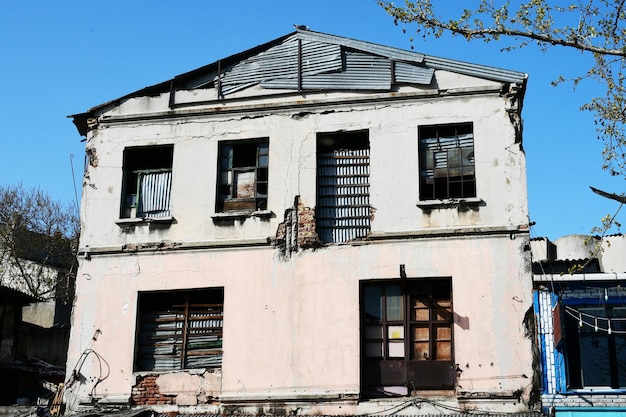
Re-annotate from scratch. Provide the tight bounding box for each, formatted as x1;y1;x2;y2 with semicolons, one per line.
361;279;455;396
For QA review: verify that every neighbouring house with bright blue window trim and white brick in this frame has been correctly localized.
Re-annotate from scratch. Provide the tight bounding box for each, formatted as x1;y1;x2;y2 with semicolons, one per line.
532;235;626;417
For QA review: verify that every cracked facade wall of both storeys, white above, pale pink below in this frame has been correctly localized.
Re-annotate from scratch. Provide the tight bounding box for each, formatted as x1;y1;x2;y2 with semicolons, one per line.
66;72;533;414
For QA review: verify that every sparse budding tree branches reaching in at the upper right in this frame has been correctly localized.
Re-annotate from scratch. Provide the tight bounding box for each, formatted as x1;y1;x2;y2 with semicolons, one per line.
378;0;626;224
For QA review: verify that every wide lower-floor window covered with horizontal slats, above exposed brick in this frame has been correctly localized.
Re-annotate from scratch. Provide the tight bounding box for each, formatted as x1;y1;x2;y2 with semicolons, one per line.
135;288;224;371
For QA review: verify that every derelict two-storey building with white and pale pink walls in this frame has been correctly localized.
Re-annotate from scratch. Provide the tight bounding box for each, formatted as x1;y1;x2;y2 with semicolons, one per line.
65;29;540;415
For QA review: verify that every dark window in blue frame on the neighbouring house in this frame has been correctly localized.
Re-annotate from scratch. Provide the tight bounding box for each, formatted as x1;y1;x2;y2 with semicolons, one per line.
560;305;626;389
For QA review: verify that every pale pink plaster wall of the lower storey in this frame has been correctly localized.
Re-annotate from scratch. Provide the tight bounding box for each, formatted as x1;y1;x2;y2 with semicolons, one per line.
67;236;532;406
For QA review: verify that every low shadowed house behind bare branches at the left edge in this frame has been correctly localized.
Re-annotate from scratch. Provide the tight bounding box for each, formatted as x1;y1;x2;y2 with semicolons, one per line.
0;224;75;406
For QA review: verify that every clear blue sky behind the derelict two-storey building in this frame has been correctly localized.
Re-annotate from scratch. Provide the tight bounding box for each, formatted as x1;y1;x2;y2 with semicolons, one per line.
0;0;624;239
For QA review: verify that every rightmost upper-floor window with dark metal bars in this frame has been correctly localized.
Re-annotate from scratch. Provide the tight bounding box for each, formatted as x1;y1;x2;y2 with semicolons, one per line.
419;123;476;200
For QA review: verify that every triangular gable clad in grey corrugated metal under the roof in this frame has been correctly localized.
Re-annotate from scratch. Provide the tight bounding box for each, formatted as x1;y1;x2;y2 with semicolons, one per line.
69;28;527;135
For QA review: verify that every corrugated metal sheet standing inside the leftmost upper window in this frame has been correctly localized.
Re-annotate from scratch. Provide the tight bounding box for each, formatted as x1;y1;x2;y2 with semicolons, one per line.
138;171;172;217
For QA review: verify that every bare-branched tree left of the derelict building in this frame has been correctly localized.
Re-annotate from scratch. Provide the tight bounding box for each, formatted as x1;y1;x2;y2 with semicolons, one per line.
0;184;80;301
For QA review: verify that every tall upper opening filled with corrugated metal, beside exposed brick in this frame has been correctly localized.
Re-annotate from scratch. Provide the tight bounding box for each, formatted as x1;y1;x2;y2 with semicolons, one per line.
315;131;371;243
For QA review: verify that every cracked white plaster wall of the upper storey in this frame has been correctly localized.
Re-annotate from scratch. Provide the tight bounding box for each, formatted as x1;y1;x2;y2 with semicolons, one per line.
81;88;528;248
